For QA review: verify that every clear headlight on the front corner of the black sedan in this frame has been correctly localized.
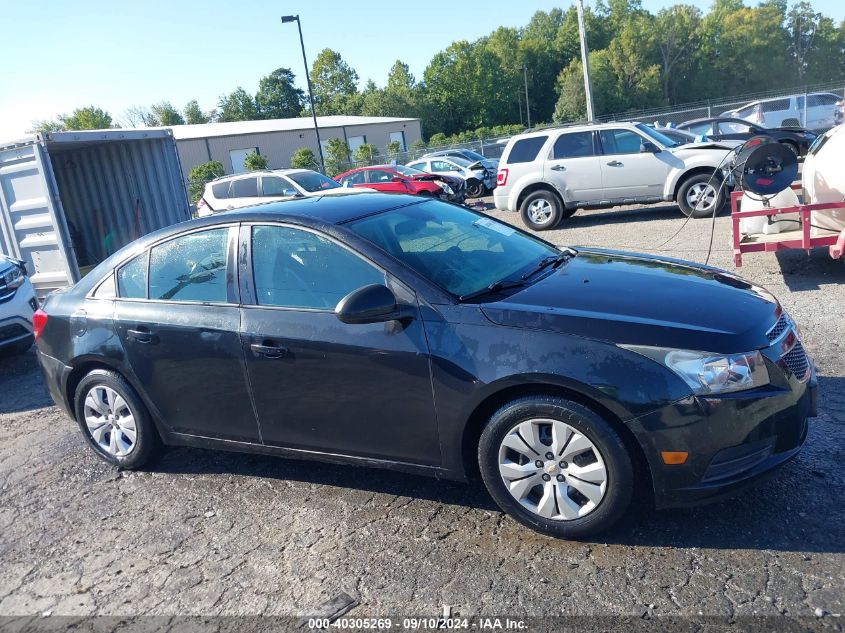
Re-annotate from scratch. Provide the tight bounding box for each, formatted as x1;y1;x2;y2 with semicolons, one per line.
627;346;769;396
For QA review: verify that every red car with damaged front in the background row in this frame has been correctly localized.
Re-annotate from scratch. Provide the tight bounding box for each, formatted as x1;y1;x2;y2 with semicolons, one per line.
335;165;466;204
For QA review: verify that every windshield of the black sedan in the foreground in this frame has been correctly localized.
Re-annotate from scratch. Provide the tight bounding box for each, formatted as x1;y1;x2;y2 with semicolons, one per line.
348;200;560;296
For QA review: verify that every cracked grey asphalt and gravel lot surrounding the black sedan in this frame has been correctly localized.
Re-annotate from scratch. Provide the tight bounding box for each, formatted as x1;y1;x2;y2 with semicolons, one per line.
0;205;845;622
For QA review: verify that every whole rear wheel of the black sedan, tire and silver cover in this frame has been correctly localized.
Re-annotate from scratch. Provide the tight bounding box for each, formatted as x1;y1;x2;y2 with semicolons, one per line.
74;369;161;470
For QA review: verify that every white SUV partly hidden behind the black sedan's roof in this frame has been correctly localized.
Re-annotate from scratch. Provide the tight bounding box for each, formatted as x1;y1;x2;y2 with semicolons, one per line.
197;169;374;217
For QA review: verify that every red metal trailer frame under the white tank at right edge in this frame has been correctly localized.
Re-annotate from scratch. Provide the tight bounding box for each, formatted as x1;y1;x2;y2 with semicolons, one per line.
731;183;845;267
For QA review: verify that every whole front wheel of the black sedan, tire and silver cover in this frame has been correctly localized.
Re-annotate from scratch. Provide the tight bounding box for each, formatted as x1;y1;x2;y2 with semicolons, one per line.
478;396;634;539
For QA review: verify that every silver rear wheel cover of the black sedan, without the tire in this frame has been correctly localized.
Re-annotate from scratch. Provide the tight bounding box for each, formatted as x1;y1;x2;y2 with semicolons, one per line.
83;385;138;457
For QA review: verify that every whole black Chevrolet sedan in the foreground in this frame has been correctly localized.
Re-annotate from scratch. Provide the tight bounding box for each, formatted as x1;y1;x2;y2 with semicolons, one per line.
34;194;816;537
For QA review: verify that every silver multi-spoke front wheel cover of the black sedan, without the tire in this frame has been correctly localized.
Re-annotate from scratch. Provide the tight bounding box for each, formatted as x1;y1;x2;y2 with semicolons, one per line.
499;418;608;521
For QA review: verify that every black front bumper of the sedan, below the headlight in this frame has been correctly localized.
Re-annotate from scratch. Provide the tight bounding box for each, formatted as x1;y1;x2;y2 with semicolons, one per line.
634;362;817;508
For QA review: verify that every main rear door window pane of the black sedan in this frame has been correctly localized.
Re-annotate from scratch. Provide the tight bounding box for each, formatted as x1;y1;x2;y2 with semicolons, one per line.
150;228;229;302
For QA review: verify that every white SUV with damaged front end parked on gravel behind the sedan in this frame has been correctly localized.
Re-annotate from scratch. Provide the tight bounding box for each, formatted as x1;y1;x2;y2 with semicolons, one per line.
493;123;736;231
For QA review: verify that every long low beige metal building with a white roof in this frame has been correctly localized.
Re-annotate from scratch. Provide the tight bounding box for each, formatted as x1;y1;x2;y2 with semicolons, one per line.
169;116;422;181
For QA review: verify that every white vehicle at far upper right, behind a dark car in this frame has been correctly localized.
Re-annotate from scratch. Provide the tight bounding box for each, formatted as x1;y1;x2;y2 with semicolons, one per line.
722;92;842;131
